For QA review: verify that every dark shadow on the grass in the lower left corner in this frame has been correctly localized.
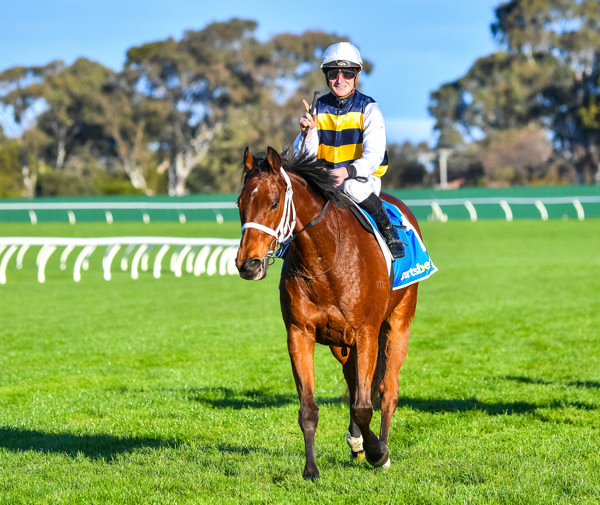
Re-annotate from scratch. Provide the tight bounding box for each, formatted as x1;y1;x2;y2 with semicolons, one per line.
0;426;175;462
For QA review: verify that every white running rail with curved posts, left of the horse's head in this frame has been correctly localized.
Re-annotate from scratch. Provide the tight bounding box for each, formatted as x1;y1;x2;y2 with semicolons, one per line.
0;237;239;284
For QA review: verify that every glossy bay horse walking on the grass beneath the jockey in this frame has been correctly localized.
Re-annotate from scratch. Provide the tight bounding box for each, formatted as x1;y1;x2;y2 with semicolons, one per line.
236;147;420;481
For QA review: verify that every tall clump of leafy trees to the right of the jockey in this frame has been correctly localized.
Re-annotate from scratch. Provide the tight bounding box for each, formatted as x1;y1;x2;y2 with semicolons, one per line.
430;0;600;184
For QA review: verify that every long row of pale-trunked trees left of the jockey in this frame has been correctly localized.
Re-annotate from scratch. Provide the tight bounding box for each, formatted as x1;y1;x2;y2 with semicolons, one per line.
0;19;371;195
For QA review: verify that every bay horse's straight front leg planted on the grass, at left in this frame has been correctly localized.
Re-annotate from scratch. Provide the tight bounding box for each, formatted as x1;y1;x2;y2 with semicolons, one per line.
288;327;319;481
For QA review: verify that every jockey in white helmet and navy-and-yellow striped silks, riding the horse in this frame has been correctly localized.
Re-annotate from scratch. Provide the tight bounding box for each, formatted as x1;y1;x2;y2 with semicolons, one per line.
294;42;405;258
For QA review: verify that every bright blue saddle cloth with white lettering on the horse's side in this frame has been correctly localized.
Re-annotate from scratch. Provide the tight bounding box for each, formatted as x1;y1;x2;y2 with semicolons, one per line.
363;201;438;290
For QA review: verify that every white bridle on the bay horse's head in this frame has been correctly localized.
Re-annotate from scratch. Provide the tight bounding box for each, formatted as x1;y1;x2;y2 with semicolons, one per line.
242;167;331;265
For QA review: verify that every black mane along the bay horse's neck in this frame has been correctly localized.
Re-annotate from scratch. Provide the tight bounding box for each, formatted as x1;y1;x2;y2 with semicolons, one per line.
244;149;352;209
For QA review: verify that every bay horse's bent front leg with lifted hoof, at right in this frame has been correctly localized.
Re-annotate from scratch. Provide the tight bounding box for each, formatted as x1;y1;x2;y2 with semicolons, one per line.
350;334;390;467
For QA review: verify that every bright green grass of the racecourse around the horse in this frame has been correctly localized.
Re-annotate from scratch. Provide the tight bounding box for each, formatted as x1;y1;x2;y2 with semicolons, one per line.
0;220;600;504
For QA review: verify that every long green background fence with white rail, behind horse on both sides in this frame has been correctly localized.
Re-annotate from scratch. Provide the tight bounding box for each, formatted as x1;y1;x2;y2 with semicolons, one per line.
0;186;600;224
